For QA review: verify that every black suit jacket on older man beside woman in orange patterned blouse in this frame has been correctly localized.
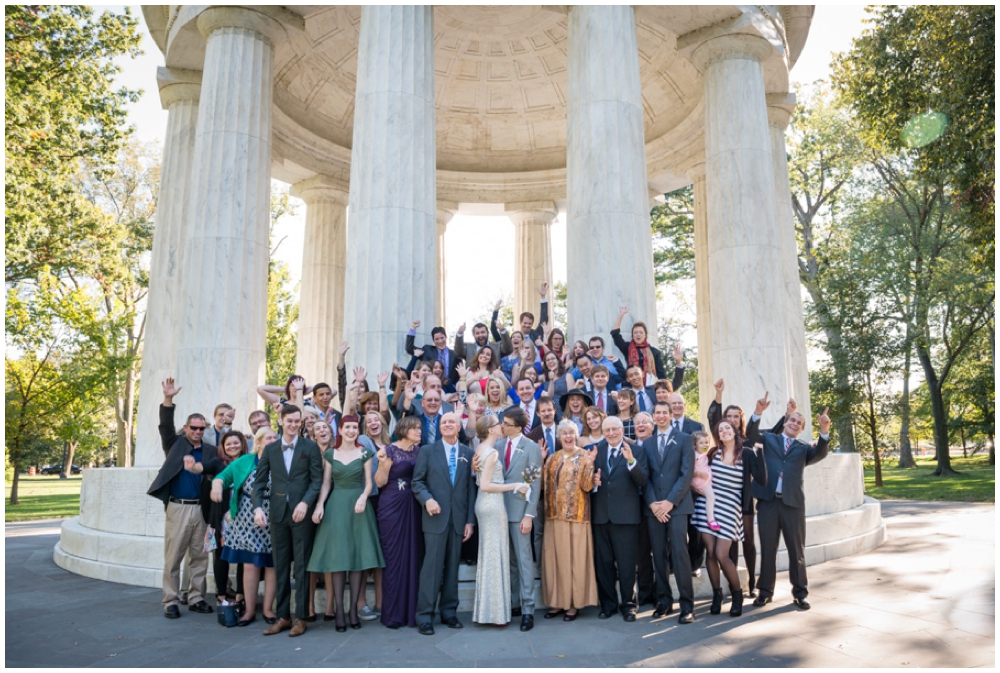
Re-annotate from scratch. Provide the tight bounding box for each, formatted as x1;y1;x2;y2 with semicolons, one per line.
590;439;648;524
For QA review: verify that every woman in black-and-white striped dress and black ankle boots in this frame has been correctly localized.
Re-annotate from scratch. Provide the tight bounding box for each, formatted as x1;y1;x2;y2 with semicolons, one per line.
692;421;767;617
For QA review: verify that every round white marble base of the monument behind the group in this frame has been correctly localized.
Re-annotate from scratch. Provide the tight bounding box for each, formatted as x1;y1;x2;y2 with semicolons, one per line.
53;454;885;612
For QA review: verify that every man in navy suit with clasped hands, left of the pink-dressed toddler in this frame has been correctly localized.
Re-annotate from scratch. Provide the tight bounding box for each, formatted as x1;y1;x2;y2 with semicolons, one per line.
642;402;694;624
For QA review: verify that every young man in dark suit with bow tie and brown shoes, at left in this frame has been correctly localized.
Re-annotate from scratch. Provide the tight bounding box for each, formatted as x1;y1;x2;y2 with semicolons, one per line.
253;404;323;636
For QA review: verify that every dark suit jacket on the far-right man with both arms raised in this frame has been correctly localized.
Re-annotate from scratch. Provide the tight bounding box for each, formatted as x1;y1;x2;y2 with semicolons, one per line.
747;419;830;507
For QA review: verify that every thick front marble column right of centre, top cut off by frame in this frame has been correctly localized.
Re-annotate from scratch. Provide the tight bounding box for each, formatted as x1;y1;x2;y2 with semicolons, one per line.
566;5;657;350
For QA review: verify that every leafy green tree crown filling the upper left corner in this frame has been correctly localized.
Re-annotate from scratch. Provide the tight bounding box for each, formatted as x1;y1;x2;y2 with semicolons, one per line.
4;5;141;283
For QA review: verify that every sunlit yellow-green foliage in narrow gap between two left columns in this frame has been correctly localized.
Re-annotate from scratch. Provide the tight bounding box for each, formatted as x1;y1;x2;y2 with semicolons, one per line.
267;184;299;385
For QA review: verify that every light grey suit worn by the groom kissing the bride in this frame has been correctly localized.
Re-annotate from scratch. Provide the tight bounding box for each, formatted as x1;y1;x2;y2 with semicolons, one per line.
497;435;542;615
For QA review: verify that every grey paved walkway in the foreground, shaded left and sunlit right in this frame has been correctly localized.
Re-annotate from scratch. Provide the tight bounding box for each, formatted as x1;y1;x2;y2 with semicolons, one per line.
5;501;996;668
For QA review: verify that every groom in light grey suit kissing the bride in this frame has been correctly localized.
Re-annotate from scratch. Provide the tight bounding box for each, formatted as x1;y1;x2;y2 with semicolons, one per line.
497;407;542;631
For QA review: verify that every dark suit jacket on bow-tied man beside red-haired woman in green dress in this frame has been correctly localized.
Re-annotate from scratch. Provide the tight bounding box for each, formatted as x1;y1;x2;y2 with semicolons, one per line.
253;437;323;523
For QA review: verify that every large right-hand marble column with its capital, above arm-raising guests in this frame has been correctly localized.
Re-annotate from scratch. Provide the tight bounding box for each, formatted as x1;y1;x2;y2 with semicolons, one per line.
693;35;789;427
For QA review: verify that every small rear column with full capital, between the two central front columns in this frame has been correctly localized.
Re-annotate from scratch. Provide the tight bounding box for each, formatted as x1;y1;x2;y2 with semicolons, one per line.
504;201;559;321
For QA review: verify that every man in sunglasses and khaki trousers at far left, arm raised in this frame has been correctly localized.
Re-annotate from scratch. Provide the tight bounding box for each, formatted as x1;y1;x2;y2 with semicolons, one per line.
147;379;218;619
